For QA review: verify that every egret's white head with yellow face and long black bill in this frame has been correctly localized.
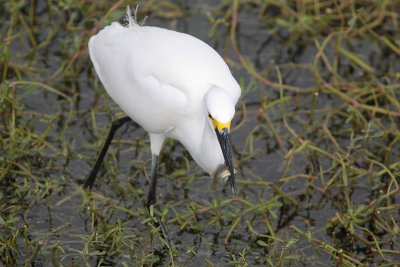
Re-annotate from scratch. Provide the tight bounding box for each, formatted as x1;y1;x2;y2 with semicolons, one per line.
205;88;235;193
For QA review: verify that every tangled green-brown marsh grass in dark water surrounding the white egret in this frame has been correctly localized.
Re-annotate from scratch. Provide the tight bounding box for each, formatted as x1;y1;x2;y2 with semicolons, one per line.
0;0;400;266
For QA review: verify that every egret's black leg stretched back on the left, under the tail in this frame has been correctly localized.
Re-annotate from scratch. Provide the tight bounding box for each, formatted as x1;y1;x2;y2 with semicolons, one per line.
83;117;132;188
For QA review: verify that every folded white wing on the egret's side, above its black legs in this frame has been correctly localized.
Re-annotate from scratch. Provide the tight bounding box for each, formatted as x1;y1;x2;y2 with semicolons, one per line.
89;23;188;132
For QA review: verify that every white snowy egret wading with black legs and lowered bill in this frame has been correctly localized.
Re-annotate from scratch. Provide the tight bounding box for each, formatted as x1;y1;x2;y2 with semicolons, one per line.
84;7;241;206
